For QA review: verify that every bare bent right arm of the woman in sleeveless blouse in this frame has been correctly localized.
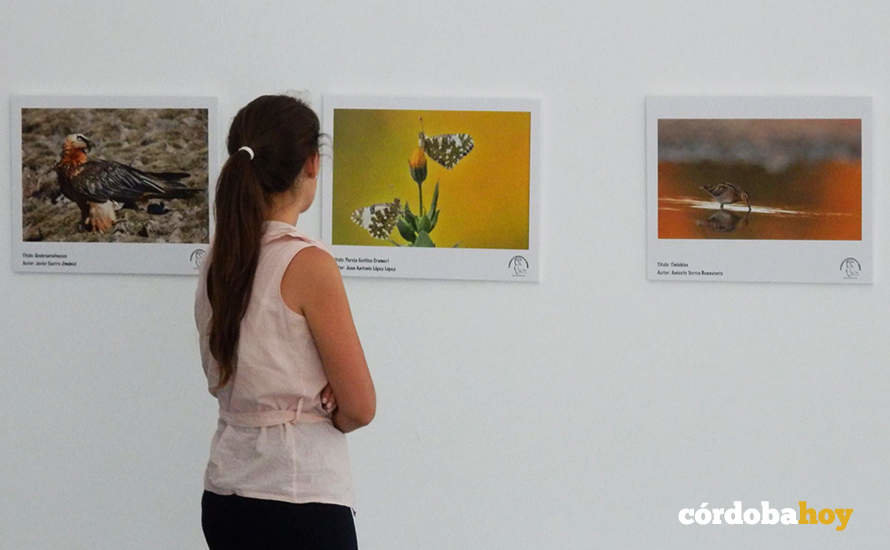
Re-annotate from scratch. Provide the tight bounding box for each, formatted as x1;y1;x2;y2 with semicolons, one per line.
281;246;377;433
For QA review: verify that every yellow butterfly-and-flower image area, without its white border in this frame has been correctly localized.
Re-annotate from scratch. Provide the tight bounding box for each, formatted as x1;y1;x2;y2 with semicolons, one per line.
331;104;530;249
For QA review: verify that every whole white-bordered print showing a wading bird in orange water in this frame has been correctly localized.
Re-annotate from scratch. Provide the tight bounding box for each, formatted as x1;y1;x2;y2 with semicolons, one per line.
646;97;874;284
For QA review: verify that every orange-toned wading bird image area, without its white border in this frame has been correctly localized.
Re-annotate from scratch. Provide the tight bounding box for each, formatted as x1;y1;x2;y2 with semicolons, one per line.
658;118;862;241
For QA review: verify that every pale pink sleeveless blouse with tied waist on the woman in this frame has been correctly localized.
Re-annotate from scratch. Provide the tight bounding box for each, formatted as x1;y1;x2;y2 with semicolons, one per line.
195;221;355;511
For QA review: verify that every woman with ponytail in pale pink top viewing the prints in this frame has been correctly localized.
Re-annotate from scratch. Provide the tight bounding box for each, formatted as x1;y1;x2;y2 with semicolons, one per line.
195;96;376;550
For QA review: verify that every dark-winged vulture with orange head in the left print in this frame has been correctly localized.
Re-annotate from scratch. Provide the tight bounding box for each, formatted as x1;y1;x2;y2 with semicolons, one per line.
53;134;202;233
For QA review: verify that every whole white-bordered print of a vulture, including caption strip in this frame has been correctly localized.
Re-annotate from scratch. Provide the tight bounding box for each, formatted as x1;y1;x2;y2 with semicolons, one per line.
10;96;218;274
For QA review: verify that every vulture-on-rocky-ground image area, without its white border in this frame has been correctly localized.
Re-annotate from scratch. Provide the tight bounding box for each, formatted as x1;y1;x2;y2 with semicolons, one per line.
22;108;209;243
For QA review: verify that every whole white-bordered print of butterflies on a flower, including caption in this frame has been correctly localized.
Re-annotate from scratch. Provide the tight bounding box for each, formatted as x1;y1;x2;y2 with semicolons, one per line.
322;95;541;282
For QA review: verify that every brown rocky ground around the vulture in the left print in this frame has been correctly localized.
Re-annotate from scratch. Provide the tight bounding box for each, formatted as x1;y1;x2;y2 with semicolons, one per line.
22;109;209;243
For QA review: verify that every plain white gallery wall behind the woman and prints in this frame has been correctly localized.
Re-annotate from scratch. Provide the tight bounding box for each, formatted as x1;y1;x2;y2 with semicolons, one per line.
0;0;890;549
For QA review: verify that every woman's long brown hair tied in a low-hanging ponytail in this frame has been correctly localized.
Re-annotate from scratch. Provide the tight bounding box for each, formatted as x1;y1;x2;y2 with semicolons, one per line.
207;95;320;388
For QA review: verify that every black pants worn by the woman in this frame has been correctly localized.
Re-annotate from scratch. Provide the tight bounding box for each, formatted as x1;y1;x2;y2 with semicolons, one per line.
201;491;358;550
